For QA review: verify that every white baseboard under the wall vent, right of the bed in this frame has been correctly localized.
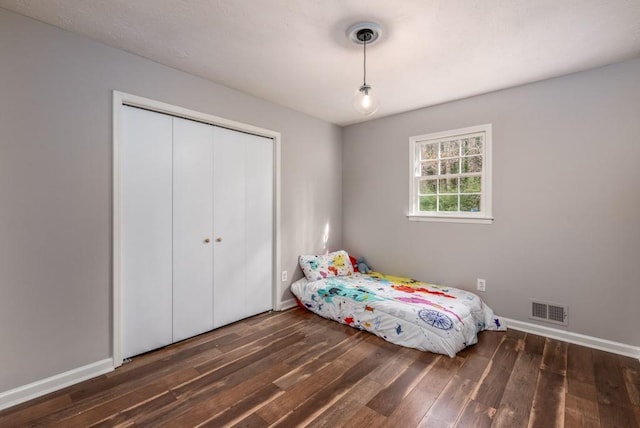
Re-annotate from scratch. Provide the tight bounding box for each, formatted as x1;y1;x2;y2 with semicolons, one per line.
503;318;640;359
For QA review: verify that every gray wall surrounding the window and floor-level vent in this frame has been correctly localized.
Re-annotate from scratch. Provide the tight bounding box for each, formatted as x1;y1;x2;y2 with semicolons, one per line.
343;60;640;346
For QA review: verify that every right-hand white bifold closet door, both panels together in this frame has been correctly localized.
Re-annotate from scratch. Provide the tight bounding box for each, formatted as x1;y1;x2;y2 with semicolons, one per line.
213;128;273;327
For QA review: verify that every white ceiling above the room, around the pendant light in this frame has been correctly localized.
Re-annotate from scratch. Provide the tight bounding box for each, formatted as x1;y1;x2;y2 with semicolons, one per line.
0;0;640;125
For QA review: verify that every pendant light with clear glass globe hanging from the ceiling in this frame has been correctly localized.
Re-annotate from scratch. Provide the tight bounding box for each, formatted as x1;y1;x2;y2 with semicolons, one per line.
347;22;382;116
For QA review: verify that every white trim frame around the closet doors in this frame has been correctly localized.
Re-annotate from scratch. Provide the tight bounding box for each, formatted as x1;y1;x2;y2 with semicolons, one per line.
112;91;282;367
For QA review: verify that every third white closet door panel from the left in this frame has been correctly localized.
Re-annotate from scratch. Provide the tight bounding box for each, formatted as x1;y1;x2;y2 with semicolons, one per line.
213;127;246;327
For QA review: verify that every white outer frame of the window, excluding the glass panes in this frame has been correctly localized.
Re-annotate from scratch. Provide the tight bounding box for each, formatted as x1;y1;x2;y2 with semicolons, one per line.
407;123;494;224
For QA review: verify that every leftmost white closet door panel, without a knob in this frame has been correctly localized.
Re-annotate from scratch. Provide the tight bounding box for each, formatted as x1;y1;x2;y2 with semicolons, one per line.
120;106;172;358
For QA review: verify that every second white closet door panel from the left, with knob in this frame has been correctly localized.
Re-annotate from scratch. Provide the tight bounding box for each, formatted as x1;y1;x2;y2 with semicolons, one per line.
173;118;214;342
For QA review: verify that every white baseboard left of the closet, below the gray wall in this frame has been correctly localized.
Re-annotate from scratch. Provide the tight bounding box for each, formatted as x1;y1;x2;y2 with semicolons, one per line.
0;358;113;410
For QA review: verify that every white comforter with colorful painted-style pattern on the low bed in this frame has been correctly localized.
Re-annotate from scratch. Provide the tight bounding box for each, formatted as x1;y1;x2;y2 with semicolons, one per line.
291;272;506;357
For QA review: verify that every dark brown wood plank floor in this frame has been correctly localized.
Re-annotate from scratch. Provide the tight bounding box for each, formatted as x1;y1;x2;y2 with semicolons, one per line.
0;309;640;428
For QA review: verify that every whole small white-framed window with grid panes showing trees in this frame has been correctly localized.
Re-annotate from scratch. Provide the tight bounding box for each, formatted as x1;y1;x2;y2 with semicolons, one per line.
408;124;493;223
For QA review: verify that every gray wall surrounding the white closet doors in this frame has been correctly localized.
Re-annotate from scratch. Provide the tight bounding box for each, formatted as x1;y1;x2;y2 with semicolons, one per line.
0;9;342;392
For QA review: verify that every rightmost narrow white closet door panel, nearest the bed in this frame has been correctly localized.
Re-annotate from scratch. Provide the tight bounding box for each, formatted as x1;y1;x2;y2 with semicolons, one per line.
243;134;274;316
